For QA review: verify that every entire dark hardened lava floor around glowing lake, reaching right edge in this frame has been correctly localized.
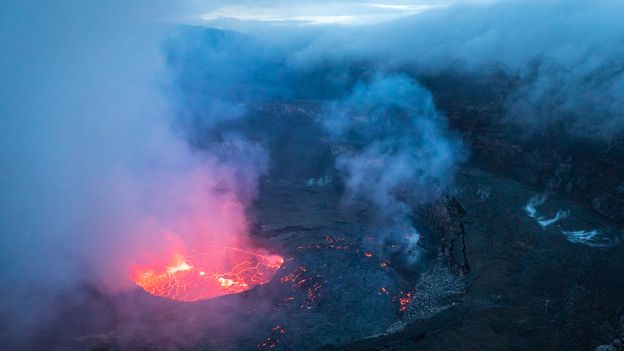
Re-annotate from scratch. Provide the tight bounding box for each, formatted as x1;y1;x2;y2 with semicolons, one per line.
69;100;624;350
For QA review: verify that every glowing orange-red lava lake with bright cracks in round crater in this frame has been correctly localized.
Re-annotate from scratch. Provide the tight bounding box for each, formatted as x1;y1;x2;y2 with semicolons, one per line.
134;246;284;301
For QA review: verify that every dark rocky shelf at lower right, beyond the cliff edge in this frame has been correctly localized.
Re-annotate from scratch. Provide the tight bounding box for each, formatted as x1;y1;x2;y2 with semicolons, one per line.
341;169;624;351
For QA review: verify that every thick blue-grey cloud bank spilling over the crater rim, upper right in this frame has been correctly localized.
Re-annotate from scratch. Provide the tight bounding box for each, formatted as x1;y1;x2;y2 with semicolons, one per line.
286;0;624;141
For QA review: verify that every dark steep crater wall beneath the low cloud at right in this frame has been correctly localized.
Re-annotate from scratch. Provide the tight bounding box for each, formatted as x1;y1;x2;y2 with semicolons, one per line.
423;73;624;223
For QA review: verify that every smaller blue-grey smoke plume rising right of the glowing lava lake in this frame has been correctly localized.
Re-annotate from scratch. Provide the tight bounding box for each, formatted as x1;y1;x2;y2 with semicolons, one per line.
324;75;465;253
